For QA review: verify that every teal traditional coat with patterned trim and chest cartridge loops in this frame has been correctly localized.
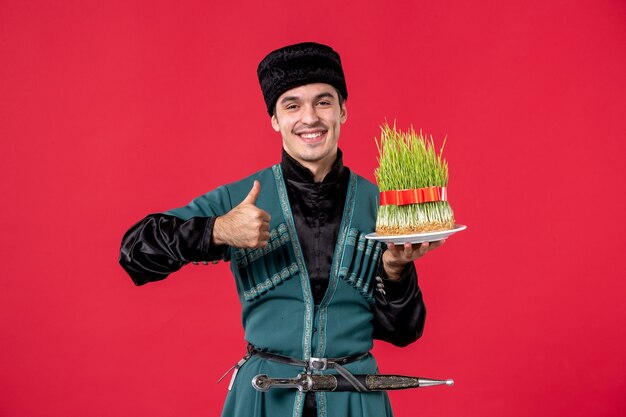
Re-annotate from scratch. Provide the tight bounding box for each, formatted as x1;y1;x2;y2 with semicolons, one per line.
168;165;392;417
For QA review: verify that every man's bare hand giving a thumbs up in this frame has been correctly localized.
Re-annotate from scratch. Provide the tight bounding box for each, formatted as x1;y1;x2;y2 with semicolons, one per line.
211;180;271;249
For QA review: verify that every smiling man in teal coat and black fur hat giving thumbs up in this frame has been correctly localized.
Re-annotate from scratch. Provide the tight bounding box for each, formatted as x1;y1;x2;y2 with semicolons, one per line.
120;43;441;417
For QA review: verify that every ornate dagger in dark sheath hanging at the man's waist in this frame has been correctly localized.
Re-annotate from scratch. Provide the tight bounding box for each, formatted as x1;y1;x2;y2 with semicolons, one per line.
252;373;454;392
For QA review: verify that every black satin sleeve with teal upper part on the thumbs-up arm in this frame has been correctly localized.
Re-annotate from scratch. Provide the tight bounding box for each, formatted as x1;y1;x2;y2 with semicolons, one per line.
119;187;230;285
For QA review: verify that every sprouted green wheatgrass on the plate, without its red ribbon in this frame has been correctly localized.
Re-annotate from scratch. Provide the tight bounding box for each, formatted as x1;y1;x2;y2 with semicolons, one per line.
374;122;454;236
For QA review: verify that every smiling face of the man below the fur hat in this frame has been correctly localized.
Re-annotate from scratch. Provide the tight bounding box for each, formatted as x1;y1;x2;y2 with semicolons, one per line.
272;83;347;181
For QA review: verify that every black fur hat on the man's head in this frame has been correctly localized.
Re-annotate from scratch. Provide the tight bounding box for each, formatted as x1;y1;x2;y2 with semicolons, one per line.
257;42;348;116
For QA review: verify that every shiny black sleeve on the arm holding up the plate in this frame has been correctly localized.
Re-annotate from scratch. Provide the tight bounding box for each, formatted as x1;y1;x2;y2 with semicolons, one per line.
373;261;426;346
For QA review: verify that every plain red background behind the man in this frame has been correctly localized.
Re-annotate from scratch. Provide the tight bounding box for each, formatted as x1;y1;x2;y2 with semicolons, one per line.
0;0;626;417
